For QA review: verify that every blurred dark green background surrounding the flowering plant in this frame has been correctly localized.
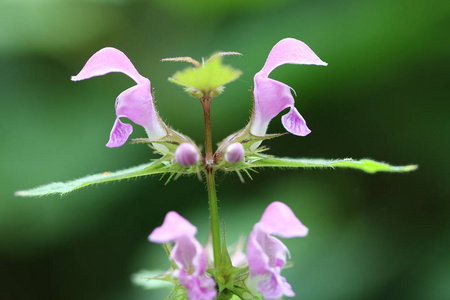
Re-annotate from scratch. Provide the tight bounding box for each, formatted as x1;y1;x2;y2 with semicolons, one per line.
0;0;450;300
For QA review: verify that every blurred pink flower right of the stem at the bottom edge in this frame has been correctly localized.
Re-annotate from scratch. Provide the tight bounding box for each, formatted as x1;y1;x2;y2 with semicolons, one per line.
247;202;308;299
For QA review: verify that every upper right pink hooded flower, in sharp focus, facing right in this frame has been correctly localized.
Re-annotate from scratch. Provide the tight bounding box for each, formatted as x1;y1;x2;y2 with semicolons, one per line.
250;38;327;136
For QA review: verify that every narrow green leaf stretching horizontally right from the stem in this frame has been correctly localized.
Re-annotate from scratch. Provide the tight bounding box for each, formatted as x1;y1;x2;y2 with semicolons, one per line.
242;155;417;173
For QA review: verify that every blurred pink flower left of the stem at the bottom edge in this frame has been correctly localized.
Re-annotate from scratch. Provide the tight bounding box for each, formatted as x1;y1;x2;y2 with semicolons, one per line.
149;211;217;300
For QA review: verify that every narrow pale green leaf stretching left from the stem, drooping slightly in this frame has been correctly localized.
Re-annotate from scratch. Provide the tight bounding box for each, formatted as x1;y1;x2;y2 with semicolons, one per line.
15;161;172;197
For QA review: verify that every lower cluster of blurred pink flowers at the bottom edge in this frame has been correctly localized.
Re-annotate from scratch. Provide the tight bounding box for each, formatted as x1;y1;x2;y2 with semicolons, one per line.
149;202;308;300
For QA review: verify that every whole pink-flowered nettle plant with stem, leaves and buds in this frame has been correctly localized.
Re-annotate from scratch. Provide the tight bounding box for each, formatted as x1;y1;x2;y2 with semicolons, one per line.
16;38;416;300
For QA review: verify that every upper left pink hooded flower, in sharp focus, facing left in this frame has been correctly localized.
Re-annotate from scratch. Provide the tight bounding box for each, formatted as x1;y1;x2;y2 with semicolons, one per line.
72;48;167;148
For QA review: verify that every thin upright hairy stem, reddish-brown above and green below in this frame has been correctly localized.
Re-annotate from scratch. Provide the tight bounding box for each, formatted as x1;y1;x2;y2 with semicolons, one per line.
200;97;221;267
